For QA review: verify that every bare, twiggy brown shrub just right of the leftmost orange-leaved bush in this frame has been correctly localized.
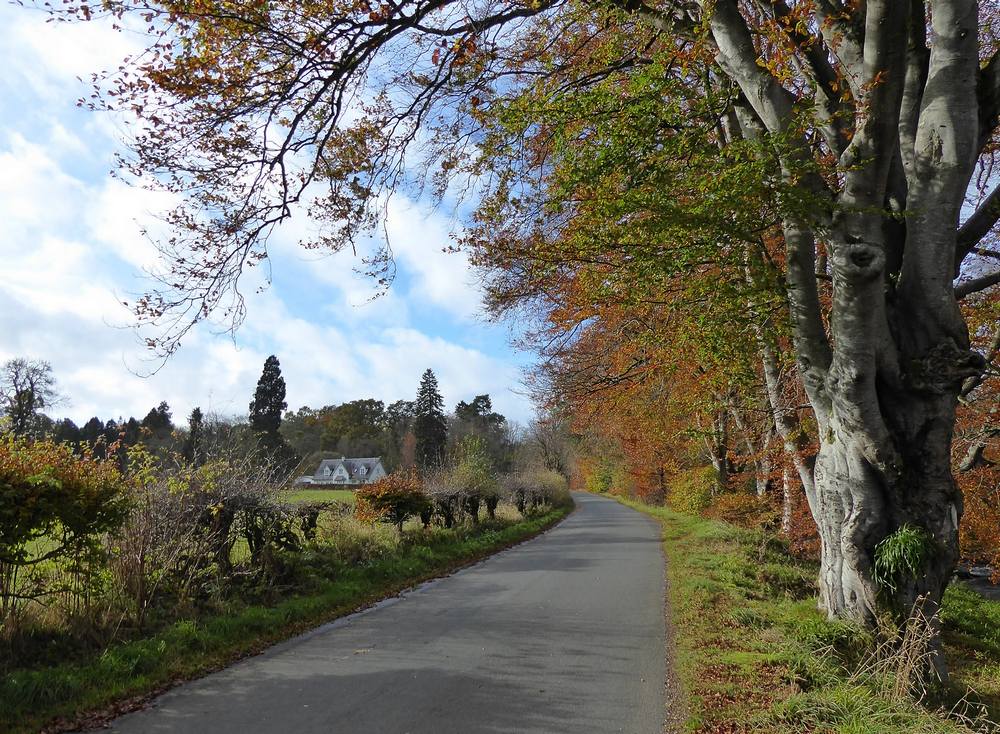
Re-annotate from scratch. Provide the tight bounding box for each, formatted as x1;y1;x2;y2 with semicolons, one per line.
107;445;301;628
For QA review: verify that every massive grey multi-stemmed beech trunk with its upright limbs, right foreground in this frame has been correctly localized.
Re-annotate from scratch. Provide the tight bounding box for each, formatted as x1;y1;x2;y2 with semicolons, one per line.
712;0;1000;648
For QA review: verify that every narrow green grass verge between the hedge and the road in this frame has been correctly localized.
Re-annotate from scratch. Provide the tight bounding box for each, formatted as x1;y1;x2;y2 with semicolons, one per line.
0;508;570;734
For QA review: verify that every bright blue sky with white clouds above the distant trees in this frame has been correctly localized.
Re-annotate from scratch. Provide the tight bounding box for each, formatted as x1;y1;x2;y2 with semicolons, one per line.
0;3;532;422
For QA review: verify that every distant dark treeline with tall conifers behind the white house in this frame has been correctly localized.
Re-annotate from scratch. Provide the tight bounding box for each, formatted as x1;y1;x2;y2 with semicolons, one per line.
0;356;536;484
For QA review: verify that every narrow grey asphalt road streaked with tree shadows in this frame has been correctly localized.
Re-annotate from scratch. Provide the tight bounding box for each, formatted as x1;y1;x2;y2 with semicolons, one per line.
112;494;666;734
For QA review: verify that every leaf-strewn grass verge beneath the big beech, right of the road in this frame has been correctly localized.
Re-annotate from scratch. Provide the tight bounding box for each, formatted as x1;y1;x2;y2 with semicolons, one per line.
617;498;1000;734
